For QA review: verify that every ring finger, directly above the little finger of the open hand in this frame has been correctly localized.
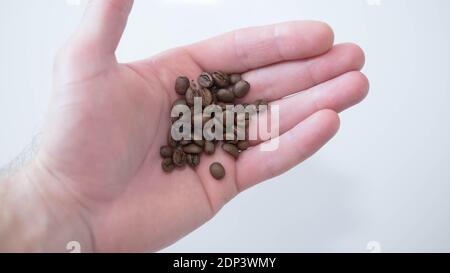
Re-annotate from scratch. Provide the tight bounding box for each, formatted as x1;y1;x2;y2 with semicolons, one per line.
250;71;369;145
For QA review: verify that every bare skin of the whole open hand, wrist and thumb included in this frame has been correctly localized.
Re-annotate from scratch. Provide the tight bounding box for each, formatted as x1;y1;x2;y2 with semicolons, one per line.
0;0;368;252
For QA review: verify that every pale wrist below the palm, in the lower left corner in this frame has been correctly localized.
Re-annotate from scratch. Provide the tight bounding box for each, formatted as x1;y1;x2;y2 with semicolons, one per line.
0;161;93;252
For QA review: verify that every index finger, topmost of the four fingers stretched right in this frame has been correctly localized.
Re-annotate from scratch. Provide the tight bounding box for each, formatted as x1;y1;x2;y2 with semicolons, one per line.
187;21;334;72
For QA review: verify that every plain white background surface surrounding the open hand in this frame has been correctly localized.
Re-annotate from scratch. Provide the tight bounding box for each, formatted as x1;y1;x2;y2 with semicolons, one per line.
0;0;450;252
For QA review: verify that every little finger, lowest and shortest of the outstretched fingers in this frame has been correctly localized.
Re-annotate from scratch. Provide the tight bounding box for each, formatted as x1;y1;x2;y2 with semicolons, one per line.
236;110;339;191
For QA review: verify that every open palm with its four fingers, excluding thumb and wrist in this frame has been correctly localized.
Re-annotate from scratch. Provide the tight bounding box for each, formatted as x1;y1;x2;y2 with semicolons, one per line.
40;0;367;250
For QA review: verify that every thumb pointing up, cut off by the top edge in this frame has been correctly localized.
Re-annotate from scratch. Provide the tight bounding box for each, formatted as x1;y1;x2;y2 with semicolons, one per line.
54;0;133;85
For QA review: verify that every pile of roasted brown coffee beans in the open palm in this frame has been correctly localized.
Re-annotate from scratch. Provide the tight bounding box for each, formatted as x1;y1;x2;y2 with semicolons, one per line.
160;71;267;180
